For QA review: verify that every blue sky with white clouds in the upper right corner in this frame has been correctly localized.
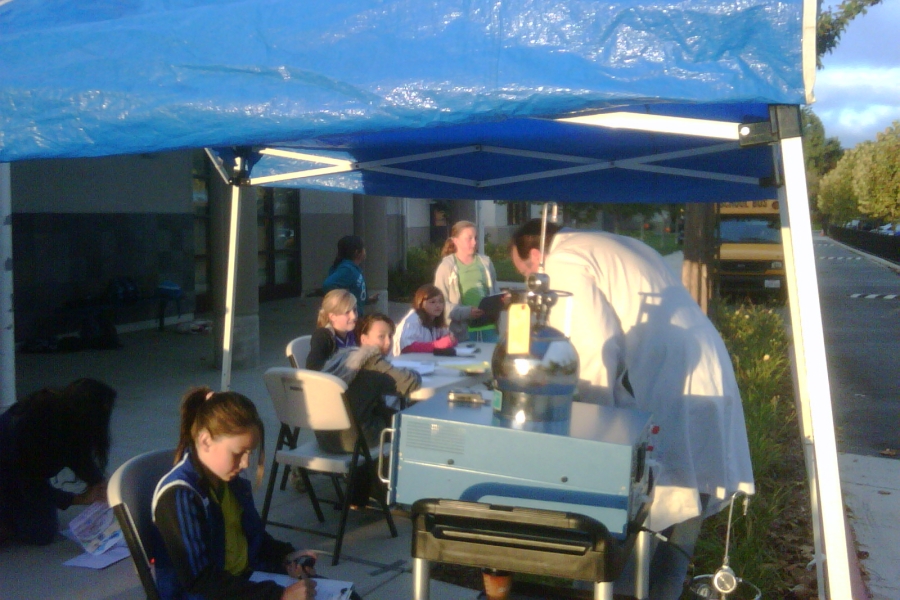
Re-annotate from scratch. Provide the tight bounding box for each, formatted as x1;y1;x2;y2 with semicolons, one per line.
812;0;900;148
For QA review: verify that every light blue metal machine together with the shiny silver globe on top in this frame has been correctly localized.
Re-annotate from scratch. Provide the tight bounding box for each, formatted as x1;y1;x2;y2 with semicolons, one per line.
382;203;652;539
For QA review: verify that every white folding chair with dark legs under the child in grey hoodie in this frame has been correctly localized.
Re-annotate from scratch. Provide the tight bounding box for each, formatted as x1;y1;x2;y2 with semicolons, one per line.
261;367;397;565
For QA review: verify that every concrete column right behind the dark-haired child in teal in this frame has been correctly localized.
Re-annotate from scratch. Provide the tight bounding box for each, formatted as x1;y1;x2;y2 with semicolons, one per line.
353;194;388;314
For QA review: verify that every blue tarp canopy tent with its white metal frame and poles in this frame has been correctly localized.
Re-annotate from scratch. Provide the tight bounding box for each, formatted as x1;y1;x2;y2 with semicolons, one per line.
0;0;850;598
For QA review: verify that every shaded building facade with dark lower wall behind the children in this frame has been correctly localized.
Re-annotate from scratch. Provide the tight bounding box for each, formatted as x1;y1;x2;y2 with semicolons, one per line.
10;150;532;343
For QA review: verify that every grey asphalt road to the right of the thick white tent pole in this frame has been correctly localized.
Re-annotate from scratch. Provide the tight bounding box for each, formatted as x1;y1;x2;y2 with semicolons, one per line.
813;237;900;456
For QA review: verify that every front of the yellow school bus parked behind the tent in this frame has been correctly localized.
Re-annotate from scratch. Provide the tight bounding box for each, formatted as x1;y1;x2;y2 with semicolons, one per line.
716;200;785;296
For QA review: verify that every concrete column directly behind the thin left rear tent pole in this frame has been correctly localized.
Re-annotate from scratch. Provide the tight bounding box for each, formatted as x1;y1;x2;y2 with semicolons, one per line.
209;177;259;369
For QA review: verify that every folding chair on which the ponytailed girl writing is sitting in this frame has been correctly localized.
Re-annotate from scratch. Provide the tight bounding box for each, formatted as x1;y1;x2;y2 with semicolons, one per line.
106;448;175;600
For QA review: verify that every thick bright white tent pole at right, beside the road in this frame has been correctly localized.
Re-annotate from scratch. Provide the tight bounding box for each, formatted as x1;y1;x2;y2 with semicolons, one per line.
780;137;853;598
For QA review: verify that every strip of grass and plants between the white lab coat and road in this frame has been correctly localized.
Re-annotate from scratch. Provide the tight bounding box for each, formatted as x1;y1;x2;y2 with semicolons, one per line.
694;305;815;598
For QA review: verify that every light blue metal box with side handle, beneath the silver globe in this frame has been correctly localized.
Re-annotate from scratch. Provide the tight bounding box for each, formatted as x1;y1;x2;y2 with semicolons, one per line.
388;395;651;539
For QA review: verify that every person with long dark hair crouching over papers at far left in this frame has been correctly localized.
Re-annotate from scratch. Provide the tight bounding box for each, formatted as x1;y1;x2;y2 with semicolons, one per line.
0;379;116;545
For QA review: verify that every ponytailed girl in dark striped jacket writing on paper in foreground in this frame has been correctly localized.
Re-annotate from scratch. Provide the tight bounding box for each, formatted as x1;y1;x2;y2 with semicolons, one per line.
153;387;316;600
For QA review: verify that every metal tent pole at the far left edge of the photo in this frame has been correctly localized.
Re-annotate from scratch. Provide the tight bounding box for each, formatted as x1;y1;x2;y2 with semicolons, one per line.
0;163;16;412
